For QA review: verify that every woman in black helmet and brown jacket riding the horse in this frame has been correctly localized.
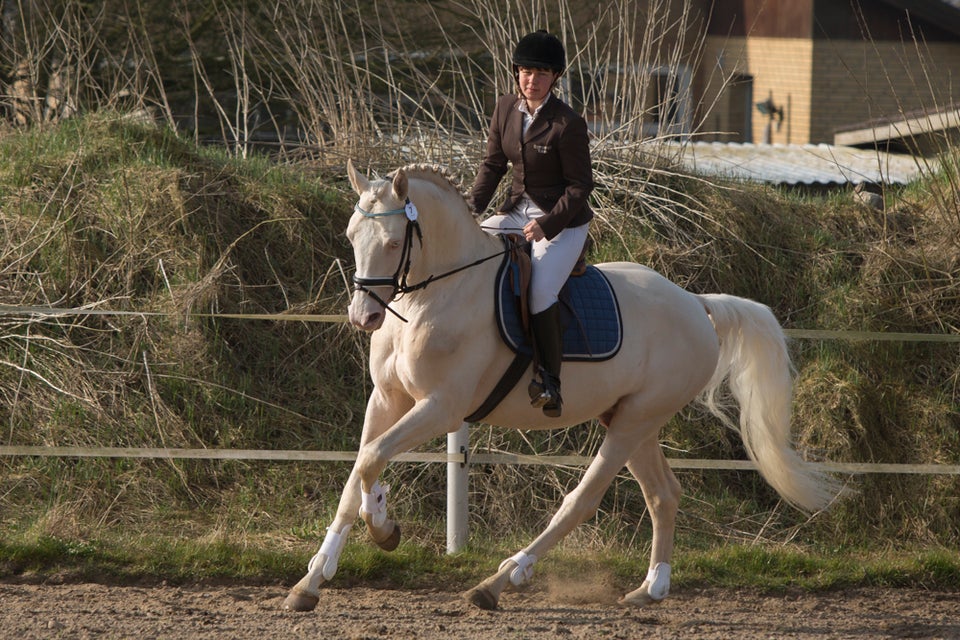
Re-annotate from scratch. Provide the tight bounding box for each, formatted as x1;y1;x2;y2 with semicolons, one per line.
469;30;593;417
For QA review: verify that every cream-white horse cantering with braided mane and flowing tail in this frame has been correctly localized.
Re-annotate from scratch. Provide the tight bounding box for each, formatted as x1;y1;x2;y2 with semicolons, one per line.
284;162;839;611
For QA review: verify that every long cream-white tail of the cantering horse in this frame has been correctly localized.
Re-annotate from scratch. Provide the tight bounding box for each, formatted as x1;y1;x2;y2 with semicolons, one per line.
699;294;841;511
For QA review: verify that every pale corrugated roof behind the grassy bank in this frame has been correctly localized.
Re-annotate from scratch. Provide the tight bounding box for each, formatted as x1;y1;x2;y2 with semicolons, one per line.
665;142;921;186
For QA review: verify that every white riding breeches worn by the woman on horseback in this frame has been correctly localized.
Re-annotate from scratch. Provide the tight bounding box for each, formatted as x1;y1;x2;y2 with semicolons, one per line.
481;198;590;313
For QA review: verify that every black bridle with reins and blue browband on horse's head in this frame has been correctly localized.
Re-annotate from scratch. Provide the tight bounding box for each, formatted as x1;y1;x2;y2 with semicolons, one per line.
353;198;512;322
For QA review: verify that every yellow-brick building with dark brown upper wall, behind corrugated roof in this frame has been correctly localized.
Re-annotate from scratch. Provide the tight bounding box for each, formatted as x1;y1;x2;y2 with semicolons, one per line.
692;0;960;147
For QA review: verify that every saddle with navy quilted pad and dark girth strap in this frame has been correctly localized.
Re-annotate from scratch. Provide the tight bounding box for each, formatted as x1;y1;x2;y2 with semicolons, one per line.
464;235;623;422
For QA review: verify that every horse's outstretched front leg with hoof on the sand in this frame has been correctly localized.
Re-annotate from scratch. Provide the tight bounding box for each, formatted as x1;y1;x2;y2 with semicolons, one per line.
283;389;411;611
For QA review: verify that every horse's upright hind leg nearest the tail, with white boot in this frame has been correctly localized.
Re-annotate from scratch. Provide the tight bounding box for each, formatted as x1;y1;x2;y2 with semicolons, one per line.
620;442;681;607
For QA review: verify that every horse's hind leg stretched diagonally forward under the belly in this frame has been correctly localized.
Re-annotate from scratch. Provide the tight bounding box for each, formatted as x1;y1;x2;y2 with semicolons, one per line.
465;413;665;609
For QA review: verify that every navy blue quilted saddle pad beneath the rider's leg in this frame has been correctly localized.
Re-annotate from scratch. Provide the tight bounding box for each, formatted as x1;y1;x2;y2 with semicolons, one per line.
495;260;623;362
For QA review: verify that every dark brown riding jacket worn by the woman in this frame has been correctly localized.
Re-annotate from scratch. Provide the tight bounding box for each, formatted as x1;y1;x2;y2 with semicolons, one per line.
469;95;593;239
